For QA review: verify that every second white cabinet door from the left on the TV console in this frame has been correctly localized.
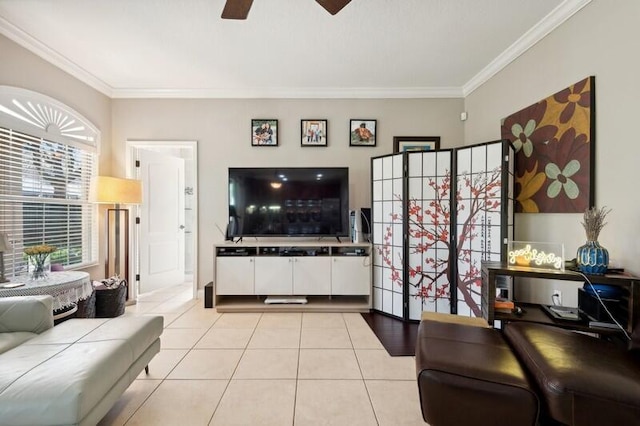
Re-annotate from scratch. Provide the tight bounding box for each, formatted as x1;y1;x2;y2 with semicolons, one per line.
255;256;294;296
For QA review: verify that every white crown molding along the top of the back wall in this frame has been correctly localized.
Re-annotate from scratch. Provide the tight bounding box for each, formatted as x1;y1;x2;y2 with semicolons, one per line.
111;87;462;99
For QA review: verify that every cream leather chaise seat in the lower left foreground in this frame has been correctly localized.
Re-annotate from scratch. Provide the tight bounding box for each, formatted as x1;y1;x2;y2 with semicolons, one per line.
0;316;163;425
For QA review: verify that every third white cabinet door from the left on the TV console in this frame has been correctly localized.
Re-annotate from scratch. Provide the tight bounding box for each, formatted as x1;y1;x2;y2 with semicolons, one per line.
293;256;331;296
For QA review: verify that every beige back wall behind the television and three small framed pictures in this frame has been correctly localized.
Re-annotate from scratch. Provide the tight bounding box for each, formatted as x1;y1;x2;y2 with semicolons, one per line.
112;99;464;286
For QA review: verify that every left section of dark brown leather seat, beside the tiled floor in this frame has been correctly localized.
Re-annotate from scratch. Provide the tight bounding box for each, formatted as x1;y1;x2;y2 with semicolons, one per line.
416;321;539;426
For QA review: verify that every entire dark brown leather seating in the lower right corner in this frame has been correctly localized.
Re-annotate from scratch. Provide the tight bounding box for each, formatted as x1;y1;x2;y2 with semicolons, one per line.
416;320;640;426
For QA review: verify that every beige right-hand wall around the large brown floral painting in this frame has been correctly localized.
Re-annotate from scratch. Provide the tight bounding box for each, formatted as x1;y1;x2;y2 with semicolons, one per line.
465;0;640;306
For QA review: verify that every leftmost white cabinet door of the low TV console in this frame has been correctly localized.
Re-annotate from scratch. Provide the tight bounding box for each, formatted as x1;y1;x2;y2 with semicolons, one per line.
216;256;254;295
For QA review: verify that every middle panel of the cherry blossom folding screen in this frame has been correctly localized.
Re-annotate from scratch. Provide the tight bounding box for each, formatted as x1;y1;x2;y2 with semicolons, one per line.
405;150;454;320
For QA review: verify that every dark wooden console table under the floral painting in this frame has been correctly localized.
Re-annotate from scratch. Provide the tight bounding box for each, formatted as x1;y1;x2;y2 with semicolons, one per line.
481;262;640;333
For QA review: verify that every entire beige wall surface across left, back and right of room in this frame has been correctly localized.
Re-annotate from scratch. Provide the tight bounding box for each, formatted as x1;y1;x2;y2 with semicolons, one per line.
7;0;640;299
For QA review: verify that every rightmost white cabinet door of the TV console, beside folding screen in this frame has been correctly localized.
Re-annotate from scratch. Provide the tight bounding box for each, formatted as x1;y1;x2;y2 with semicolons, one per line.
331;256;371;295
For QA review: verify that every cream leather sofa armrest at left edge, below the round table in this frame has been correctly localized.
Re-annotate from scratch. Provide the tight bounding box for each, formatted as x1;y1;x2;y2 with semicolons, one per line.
0;295;53;334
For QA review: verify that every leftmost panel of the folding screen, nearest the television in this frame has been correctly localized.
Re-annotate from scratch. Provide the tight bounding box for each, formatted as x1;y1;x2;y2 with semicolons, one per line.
371;154;405;319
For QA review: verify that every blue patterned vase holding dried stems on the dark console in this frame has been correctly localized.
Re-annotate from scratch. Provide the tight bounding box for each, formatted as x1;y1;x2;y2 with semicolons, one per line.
576;207;611;275
